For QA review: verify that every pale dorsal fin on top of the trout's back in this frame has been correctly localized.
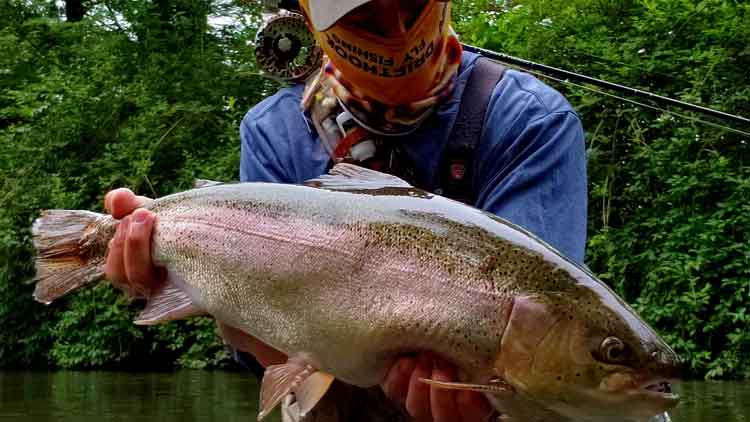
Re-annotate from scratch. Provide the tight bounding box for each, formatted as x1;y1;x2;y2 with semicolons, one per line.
305;163;414;190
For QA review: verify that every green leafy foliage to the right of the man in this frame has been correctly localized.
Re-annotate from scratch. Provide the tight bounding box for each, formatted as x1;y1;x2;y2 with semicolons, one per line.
457;0;750;378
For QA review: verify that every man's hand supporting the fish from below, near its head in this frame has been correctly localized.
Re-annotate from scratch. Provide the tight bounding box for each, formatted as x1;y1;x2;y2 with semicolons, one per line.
380;353;492;422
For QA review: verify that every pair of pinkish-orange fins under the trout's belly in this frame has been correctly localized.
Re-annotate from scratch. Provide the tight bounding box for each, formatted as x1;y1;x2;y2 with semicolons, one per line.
258;358;334;421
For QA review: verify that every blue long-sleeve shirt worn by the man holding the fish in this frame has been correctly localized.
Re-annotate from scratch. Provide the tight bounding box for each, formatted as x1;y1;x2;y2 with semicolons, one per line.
240;52;587;263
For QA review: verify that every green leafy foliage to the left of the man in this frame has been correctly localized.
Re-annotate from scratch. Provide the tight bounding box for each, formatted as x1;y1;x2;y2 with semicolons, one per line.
0;0;275;368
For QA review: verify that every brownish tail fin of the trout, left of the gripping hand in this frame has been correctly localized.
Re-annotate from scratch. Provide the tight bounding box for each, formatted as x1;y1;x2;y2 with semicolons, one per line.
32;210;118;304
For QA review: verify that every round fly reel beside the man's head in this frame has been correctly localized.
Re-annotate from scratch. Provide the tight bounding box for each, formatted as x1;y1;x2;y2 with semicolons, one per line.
255;11;323;82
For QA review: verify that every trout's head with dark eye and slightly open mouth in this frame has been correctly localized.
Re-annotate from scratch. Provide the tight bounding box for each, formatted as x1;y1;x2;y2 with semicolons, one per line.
495;289;681;421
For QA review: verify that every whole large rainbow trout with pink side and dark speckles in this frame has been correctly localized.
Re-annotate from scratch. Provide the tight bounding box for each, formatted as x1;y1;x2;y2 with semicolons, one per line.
33;165;679;422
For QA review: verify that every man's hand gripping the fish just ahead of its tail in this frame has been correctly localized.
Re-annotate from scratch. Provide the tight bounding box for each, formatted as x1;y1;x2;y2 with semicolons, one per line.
104;188;166;294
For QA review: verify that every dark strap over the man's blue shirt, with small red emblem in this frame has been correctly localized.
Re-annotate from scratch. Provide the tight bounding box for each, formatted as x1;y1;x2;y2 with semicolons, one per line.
434;57;506;205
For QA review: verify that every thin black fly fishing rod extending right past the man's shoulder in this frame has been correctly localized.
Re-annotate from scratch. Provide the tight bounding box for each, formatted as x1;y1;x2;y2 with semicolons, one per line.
462;44;750;129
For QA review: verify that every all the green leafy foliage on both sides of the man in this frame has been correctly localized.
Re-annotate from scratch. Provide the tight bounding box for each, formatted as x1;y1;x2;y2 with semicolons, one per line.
0;0;750;378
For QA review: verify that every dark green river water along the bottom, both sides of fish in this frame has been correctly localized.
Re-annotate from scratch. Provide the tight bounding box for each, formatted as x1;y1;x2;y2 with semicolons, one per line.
0;371;750;422
